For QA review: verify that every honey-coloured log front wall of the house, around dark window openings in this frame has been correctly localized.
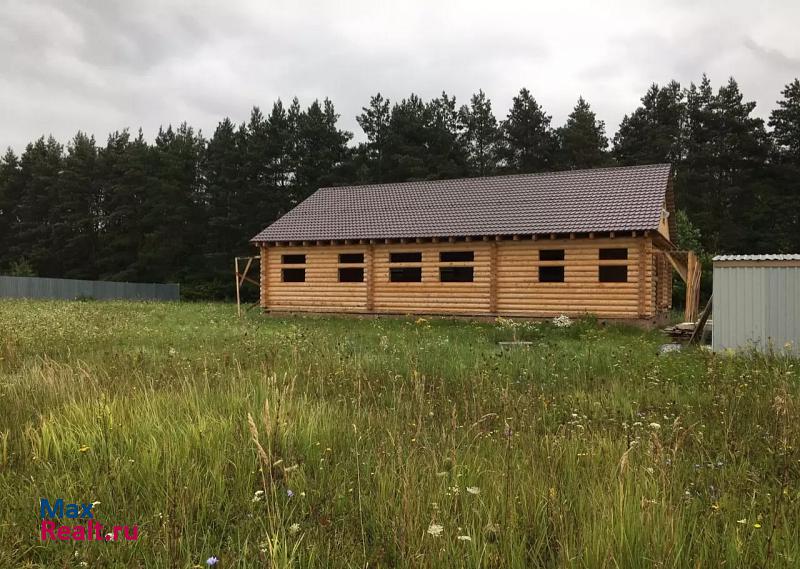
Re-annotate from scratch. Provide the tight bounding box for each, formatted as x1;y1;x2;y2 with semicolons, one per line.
261;233;666;319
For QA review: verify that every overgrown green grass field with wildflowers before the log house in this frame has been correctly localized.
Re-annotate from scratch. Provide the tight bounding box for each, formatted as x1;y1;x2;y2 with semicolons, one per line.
0;301;800;568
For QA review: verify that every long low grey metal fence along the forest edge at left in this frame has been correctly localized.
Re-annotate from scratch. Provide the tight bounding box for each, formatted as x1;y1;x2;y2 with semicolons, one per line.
0;276;181;301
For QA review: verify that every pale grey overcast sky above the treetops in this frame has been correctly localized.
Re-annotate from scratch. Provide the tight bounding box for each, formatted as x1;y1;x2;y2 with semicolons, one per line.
0;0;800;151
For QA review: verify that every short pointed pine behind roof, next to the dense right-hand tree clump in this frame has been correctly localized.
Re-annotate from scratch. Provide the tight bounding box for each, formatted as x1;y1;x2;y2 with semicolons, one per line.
558;97;608;169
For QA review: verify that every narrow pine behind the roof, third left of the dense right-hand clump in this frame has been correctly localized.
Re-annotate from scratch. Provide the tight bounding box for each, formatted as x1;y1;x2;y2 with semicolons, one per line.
459;90;500;176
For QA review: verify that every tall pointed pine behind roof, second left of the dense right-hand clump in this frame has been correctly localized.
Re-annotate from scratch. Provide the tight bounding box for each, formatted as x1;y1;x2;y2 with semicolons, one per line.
500;88;558;173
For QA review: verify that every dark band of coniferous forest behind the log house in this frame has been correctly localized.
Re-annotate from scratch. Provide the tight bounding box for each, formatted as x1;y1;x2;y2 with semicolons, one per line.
0;76;800;298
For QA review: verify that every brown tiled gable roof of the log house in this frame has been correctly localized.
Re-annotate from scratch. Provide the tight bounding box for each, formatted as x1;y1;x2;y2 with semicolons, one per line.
252;164;671;243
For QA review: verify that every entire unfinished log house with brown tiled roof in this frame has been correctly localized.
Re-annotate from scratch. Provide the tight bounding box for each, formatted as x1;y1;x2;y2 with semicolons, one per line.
252;164;699;323
